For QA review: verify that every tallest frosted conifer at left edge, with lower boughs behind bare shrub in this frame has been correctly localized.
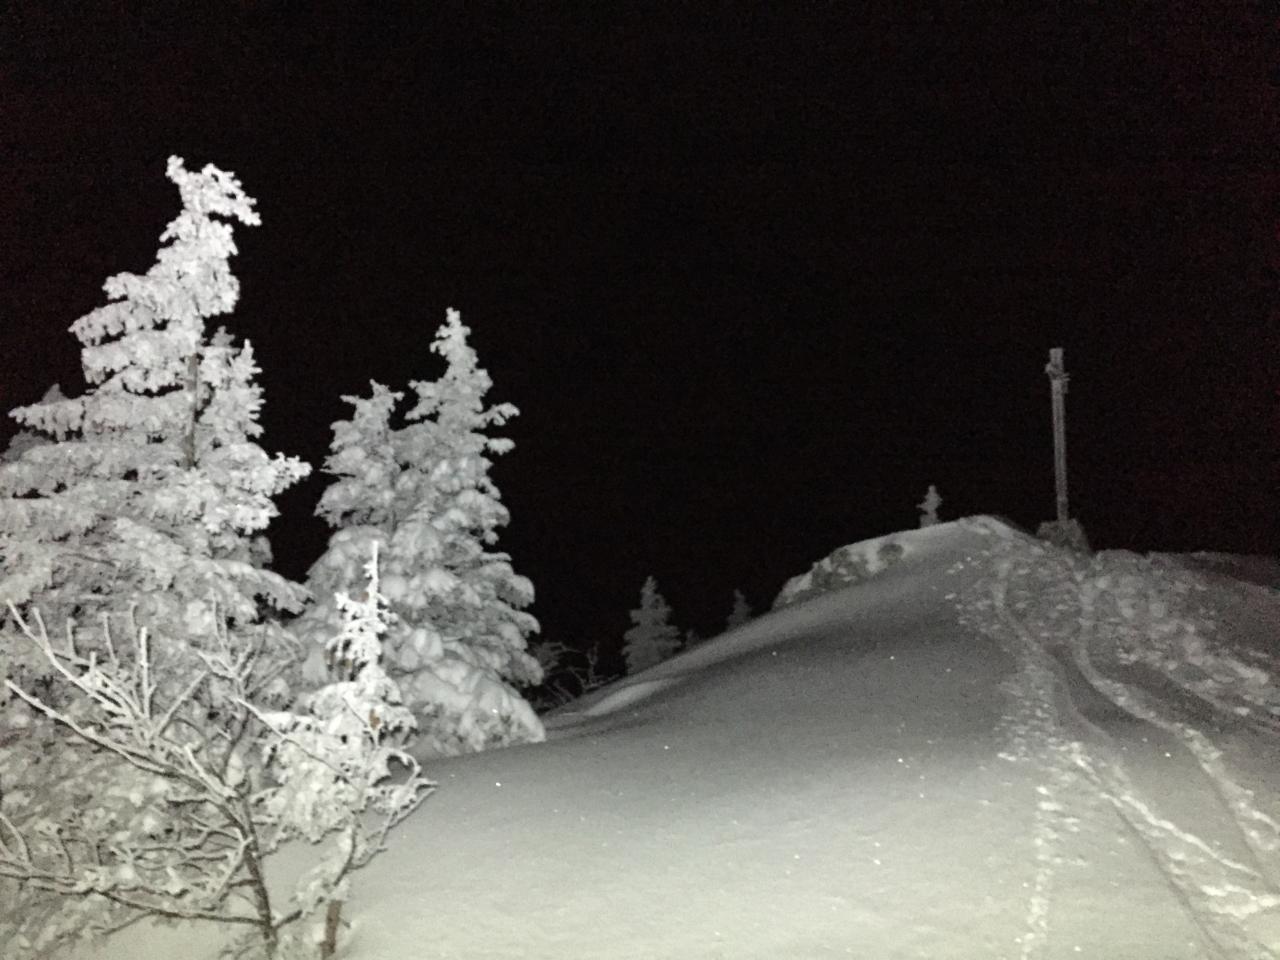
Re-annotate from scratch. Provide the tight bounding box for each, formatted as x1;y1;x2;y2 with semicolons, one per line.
0;157;307;957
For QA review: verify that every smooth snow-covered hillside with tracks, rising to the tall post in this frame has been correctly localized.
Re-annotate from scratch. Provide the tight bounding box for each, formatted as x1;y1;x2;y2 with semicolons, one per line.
67;518;1280;960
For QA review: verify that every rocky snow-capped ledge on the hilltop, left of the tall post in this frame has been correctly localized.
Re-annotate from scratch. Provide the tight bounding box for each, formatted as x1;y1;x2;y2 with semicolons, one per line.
773;516;1018;611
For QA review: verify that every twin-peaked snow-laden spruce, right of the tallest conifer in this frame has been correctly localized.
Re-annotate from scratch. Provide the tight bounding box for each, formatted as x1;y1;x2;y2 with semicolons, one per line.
298;310;543;754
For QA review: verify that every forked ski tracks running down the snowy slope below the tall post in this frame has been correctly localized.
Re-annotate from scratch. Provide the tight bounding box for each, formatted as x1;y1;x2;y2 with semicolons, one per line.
975;542;1280;960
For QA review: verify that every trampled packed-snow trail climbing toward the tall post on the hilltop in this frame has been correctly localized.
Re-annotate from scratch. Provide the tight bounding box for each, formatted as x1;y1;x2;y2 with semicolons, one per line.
975;544;1280;960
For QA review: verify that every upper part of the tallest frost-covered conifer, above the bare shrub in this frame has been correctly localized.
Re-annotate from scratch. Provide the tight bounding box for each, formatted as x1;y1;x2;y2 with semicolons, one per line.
0;157;308;639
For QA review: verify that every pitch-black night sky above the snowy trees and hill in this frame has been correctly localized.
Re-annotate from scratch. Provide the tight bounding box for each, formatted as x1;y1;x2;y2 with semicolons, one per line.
0;1;1280;660
